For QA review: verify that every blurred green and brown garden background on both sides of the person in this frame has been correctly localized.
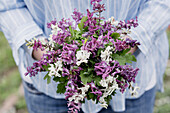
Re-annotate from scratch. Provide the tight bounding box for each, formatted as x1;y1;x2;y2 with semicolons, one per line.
0;29;170;113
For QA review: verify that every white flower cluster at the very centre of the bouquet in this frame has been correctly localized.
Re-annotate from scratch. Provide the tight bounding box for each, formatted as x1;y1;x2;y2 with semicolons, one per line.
76;50;91;66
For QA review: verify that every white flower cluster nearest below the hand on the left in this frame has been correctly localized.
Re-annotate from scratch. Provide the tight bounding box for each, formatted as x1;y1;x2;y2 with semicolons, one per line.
48;61;63;77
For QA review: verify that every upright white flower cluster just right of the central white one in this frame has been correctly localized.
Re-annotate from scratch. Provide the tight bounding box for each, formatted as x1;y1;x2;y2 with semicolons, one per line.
100;46;113;64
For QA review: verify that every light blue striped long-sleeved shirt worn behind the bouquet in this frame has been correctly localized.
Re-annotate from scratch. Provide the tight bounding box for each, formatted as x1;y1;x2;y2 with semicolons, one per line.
0;0;170;113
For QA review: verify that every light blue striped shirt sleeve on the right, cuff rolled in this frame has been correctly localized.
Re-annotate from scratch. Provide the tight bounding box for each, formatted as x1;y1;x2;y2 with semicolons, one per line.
129;0;170;55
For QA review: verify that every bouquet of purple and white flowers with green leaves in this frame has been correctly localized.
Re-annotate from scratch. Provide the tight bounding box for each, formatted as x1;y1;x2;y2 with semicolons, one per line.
26;0;140;112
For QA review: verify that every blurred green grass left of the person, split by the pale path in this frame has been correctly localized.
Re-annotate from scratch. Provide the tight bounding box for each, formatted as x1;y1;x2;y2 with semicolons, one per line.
0;32;27;113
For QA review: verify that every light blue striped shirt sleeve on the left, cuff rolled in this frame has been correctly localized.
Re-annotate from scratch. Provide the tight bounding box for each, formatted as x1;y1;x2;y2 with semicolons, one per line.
0;0;43;65
